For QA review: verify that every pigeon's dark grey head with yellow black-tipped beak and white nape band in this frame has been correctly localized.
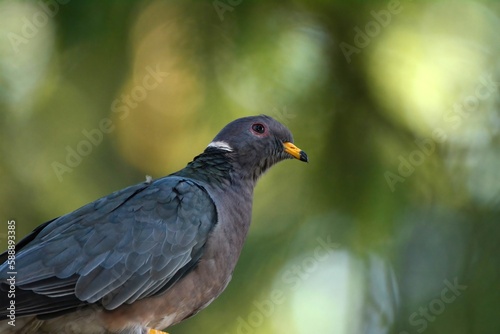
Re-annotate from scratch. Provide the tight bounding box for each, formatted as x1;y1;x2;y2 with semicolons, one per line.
206;115;308;180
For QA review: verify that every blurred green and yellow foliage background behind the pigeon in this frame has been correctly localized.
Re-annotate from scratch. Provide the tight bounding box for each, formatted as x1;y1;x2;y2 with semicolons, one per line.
0;0;500;334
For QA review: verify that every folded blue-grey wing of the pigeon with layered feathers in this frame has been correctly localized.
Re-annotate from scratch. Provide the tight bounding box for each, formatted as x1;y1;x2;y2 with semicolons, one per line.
0;177;217;316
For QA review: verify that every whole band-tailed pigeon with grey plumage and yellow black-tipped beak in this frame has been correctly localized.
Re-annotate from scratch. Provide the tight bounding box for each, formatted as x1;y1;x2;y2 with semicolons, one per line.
0;115;308;334
